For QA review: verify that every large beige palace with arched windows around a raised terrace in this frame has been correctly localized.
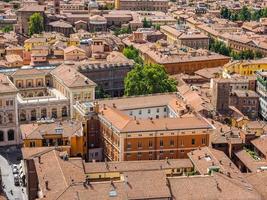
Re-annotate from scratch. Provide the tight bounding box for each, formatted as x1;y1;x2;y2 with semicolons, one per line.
0;65;96;146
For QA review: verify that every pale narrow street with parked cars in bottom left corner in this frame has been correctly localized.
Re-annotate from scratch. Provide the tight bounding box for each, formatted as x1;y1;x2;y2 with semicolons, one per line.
0;149;27;200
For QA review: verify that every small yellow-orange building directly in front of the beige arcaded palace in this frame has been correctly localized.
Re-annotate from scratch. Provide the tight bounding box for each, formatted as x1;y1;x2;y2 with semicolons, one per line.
19;120;86;157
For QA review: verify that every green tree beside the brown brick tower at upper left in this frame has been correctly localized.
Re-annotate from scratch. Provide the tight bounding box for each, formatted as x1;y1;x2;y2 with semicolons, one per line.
29;13;44;35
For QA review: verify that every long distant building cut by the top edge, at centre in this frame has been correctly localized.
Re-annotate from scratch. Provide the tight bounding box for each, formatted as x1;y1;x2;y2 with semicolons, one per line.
115;0;169;12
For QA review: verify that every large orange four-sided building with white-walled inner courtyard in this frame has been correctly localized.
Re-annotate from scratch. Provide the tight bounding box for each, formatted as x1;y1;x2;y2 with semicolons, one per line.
74;94;216;161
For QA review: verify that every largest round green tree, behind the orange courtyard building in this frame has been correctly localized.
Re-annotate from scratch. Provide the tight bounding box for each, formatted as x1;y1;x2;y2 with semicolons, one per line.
124;64;176;96
